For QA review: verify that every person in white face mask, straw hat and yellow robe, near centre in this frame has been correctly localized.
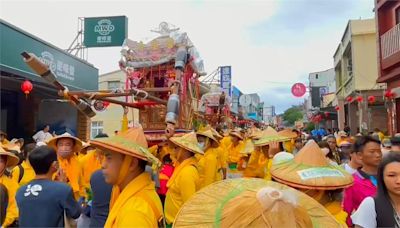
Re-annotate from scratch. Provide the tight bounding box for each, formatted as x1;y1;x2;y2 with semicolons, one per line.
197;130;219;188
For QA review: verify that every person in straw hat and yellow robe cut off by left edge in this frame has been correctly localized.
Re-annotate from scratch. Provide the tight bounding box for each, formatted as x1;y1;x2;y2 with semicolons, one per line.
0;147;19;227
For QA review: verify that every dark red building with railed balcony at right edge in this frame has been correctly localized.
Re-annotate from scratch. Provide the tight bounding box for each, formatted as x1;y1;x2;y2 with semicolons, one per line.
375;0;400;135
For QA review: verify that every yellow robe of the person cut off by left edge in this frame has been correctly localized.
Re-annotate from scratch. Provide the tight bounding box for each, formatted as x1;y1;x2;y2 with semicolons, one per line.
0;175;19;227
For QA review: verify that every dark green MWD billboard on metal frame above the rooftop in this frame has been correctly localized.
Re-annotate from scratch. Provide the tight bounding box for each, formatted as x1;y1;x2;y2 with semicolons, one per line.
83;16;128;47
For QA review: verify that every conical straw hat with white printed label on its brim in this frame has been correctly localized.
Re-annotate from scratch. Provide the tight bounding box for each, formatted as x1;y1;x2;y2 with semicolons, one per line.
271;141;353;190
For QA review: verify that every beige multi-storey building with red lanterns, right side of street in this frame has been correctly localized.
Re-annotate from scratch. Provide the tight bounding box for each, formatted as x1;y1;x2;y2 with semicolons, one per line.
334;19;387;134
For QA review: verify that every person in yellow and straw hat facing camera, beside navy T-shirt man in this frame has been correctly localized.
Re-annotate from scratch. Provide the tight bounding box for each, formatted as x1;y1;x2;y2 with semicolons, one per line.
48;133;86;200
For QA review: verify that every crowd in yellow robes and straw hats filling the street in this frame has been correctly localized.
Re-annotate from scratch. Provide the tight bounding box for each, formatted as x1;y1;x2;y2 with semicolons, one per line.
0;126;400;228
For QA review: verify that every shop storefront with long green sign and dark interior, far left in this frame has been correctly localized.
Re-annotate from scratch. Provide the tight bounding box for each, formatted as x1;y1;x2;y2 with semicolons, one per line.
0;20;98;141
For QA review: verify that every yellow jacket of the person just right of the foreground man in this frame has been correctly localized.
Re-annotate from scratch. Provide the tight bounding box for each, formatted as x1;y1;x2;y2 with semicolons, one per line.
164;157;199;224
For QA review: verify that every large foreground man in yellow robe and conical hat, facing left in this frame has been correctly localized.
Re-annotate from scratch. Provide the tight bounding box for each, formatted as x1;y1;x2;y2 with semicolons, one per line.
91;128;163;228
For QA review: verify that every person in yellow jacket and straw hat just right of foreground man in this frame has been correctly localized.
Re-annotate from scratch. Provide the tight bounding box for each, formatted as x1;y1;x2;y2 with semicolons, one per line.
164;132;204;227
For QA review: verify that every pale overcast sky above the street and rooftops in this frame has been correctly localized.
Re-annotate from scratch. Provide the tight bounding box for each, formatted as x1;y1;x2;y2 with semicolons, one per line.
0;0;374;112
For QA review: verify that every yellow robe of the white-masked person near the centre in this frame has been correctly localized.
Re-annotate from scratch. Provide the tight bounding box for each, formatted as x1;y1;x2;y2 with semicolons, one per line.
198;148;220;188
